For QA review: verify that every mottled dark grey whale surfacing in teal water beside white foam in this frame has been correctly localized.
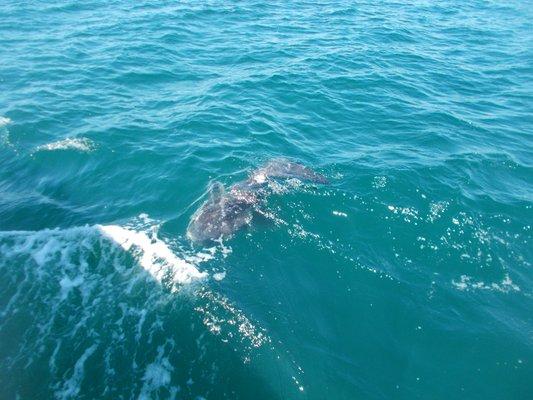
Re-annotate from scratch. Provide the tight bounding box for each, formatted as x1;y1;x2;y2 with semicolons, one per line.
187;159;327;243
